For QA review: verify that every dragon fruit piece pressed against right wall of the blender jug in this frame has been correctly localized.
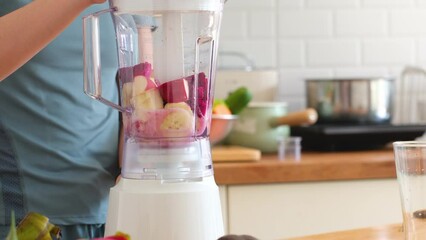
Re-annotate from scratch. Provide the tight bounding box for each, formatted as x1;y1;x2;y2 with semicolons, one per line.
186;73;209;118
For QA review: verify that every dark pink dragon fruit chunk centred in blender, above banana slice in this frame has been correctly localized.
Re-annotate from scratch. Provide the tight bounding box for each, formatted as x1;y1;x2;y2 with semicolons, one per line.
158;78;189;103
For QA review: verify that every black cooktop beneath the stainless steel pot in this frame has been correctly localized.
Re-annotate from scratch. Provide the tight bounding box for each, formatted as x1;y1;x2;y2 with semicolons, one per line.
291;124;426;151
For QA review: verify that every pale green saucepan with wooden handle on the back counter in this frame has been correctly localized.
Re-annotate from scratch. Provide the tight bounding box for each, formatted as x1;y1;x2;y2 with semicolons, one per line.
226;102;318;153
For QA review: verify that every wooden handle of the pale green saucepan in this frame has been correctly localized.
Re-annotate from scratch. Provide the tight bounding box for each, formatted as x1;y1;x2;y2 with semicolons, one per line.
269;108;318;127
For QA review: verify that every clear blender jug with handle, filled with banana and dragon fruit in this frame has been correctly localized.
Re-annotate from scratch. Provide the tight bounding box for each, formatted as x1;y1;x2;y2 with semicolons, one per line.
84;0;223;181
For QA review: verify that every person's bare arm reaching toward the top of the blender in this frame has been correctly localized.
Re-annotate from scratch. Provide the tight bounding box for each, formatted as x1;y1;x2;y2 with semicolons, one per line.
0;0;105;81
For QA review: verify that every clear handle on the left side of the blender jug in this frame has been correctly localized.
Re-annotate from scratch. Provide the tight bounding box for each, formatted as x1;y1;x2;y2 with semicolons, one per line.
83;8;126;112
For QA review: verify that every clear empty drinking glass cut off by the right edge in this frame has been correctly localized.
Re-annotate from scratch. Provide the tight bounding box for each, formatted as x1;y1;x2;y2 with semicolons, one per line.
393;141;426;240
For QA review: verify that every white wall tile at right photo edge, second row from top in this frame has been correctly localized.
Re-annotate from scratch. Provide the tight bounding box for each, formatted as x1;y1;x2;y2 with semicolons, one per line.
390;9;426;36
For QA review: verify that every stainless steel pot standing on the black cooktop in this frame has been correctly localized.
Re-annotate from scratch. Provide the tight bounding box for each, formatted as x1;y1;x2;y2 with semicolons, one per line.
305;78;394;124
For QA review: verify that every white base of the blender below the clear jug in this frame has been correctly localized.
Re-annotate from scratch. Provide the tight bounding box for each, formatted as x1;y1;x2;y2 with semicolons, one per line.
105;176;224;240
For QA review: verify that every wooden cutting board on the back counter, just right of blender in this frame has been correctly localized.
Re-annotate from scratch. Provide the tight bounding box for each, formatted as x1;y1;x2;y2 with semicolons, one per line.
212;146;262;162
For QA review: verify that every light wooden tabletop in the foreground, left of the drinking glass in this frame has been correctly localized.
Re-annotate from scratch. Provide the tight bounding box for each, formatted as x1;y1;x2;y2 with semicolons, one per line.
290;224;404;240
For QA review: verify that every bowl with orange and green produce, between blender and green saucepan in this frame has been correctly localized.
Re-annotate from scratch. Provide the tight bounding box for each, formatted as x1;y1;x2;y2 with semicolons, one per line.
210;87;252;145
